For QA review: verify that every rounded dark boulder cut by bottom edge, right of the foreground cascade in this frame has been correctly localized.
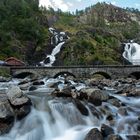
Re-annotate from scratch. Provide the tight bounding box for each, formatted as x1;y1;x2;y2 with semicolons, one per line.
84;128;103;140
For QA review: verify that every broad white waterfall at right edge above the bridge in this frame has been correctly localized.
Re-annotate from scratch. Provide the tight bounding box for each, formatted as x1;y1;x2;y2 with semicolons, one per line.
123;42;140;65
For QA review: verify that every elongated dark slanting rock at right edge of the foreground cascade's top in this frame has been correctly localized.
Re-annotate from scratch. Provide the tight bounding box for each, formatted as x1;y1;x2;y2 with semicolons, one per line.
74;99;89;116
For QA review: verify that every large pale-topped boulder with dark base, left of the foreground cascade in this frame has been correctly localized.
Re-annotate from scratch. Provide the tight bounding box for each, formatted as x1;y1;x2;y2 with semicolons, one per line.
7;86;31;119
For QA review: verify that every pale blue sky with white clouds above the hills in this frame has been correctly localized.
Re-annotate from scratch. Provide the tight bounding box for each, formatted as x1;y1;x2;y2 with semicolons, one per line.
40;0;140;11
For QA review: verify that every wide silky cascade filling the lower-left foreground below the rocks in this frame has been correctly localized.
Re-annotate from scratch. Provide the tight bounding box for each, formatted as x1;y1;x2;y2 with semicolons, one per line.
0;97;92;140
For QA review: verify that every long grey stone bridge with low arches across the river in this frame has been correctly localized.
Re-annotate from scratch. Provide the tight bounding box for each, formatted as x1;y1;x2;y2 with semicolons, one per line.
10;65;140;79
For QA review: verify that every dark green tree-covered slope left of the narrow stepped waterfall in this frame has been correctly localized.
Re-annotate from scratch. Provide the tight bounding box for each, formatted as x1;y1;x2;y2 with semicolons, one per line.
0;0;48;62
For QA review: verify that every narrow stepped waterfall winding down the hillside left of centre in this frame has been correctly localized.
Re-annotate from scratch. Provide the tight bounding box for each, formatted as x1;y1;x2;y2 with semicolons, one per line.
40;27;69;67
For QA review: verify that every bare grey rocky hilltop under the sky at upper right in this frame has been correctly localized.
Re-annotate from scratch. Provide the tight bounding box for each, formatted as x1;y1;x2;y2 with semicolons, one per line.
79;3;140;24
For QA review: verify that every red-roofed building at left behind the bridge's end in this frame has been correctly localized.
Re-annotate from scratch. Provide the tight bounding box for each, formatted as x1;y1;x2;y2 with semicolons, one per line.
5;57;25;66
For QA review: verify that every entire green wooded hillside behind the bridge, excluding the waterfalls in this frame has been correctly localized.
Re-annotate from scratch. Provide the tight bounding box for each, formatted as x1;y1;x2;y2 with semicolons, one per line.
0;0;140;65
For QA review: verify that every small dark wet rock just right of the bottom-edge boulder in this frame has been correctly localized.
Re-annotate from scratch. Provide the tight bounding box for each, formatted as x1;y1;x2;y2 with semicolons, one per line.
101;124;114;137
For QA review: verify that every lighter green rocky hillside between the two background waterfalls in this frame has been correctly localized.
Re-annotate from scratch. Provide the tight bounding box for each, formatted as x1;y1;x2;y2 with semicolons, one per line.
49;3;140;65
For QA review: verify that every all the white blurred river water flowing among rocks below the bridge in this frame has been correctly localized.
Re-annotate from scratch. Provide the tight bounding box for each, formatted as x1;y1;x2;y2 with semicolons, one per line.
0;77;140;140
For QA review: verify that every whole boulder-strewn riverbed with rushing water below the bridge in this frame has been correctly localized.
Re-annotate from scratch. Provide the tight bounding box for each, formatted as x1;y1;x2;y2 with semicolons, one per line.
0;76;140;140
